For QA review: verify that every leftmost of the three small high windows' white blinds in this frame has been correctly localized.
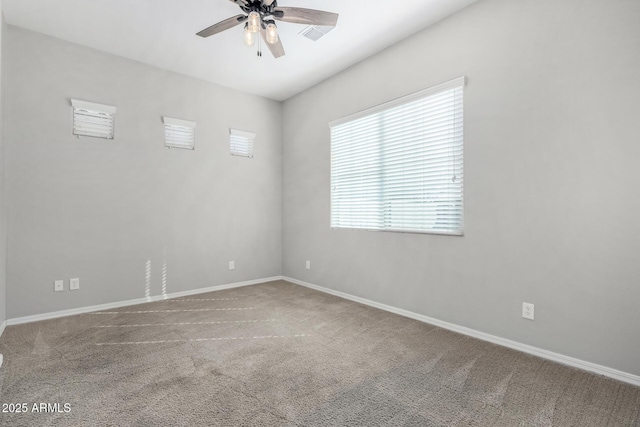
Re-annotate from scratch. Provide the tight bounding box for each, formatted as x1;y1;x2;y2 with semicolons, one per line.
71;99;116;139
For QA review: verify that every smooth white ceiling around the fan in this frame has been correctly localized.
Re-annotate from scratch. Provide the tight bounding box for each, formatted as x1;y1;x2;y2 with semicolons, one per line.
2;0;476;101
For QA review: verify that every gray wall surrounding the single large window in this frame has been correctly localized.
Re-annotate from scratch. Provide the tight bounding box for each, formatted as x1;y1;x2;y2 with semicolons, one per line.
283;0;640;375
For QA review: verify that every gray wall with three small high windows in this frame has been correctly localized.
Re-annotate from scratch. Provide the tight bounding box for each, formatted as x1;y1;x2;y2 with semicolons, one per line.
5;26;282;318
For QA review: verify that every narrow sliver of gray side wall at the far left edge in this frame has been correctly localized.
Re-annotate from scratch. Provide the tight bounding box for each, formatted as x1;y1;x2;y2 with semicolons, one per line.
0;0;7;325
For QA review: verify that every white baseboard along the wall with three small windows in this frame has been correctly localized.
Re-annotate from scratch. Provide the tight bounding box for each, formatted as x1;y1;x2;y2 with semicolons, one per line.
5;276;282;328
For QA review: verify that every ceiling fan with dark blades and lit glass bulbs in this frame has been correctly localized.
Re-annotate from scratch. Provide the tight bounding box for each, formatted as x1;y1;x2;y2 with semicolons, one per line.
196;0;338;58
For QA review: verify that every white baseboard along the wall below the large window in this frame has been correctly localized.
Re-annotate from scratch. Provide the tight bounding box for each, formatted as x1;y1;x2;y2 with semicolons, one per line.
282;277;640;386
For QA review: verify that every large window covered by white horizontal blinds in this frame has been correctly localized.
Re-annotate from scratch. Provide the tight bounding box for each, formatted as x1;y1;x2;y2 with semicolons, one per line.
329;77;465;235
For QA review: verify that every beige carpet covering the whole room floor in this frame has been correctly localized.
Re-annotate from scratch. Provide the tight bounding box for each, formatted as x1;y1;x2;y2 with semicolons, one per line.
0;282;640;427
